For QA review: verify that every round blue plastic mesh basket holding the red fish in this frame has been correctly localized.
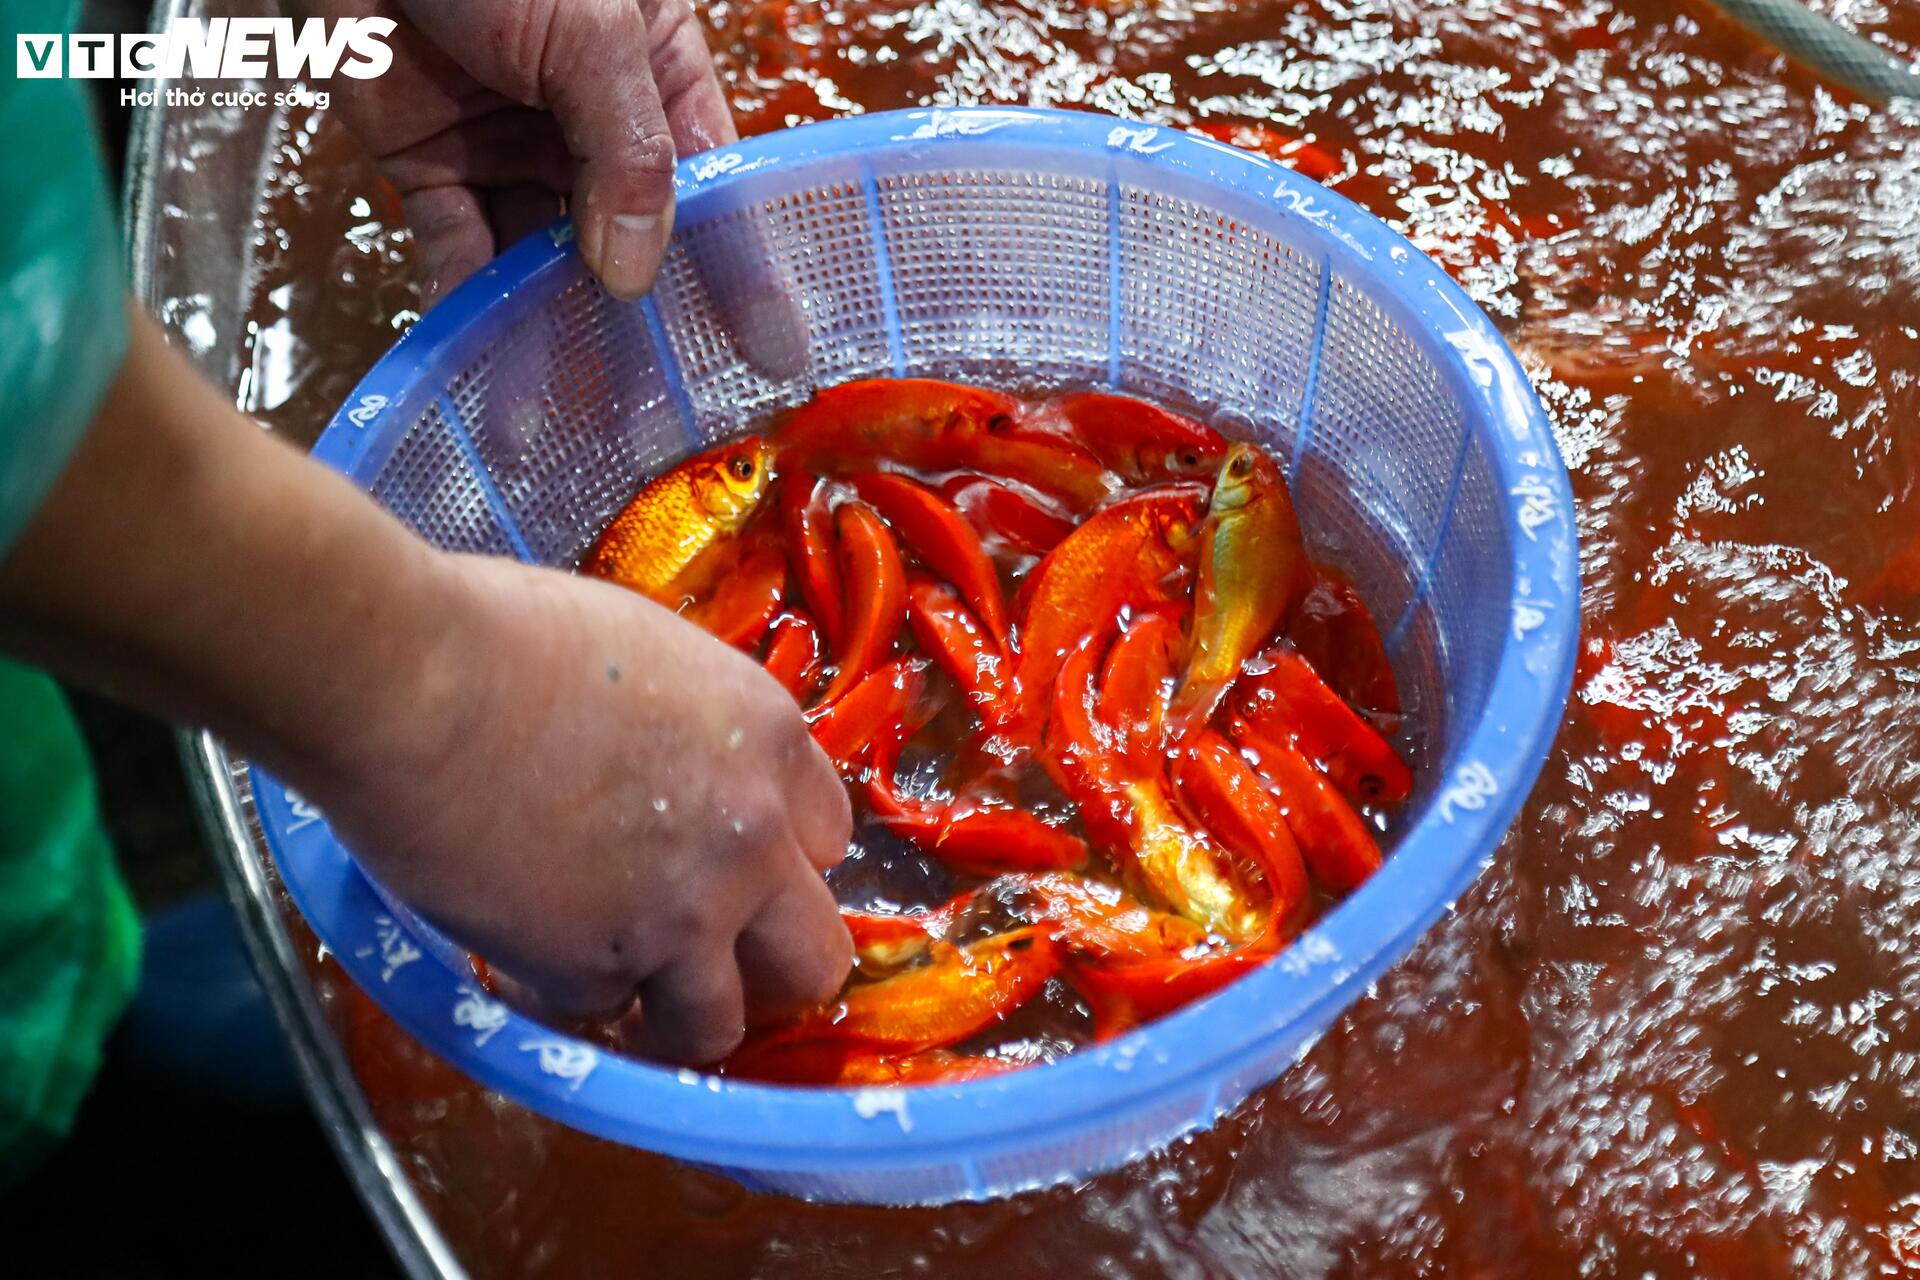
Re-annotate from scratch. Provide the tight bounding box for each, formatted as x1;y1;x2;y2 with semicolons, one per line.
255;109;1578;1203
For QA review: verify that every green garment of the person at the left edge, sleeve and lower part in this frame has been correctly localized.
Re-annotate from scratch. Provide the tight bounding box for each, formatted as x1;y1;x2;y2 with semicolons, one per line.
0;0;140;1192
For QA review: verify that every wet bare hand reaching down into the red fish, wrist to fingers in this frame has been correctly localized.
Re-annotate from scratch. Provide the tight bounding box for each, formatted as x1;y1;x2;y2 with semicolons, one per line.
301;557;852;1063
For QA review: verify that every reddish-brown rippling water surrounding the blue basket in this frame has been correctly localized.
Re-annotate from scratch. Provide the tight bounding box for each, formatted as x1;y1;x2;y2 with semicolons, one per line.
202;0;1920;1280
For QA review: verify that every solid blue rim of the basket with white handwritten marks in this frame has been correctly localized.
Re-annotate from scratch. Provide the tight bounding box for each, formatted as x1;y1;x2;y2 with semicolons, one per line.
274;107;1580;1194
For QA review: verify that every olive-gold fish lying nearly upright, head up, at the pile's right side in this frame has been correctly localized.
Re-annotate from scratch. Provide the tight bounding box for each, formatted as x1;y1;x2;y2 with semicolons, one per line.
1167;445;1311;739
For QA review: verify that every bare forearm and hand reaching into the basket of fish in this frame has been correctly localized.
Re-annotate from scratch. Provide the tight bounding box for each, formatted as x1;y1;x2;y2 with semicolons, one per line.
0;310;851;1061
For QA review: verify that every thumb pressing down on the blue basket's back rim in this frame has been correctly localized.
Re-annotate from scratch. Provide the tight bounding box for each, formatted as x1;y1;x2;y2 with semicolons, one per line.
540;0;674;299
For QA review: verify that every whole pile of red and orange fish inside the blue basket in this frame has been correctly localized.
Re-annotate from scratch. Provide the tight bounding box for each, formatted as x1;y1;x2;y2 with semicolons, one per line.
582;378;1413;1084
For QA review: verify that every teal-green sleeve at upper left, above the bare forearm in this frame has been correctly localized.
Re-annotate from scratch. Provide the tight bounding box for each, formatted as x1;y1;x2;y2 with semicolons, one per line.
0;0;127;555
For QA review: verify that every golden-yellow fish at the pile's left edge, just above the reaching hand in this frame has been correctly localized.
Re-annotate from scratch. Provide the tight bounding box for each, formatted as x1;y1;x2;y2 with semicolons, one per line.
580;436;774;604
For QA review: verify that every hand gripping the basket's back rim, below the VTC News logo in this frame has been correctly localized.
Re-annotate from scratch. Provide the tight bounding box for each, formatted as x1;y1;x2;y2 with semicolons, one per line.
307;0;737;305
